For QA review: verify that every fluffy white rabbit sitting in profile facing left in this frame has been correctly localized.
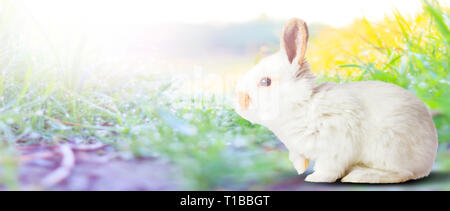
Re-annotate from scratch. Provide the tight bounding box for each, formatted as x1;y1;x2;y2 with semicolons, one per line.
235;18;438;183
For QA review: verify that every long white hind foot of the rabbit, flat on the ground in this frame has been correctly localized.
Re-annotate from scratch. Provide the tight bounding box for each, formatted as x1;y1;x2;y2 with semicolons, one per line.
341;166;410;183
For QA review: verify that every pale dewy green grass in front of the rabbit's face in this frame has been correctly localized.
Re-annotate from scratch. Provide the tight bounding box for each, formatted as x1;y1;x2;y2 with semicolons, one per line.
0;55;296;190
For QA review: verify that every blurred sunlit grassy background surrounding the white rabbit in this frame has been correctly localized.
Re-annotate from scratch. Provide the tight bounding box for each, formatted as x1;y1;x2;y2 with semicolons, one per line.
0;0;450;190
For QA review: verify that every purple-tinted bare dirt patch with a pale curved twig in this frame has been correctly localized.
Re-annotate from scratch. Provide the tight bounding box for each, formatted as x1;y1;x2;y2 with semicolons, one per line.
4;144;185;190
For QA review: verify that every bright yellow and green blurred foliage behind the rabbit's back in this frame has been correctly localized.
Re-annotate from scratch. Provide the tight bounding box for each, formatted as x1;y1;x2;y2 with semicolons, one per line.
307;1;450;142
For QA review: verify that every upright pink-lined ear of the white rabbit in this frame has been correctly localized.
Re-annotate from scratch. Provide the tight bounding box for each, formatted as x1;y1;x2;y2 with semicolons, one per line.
281;18;308;66
